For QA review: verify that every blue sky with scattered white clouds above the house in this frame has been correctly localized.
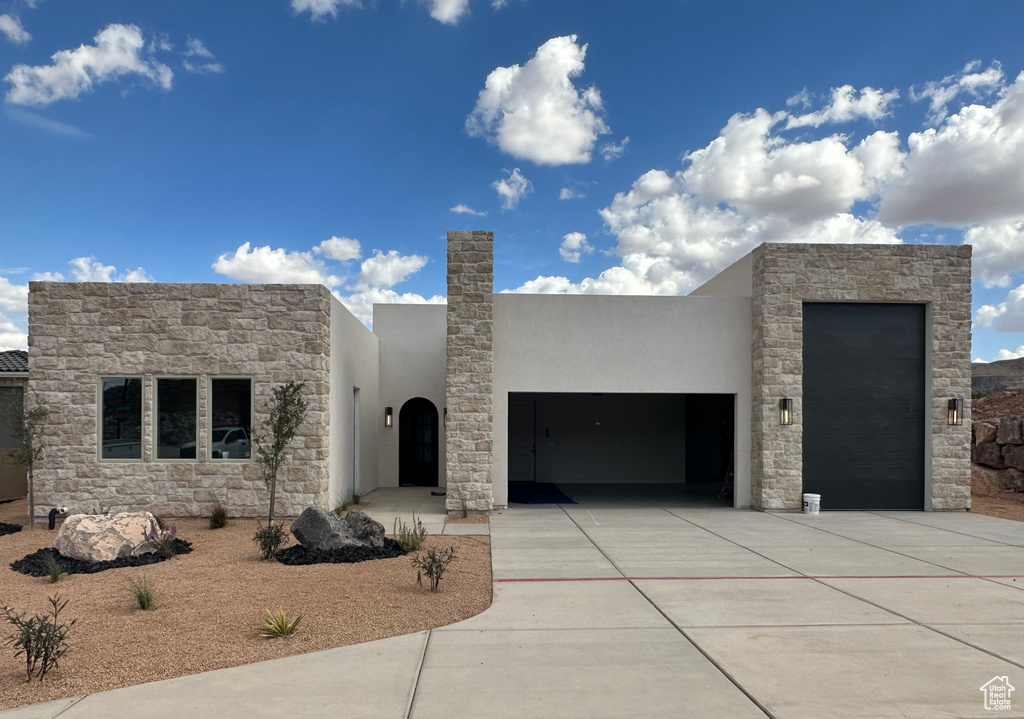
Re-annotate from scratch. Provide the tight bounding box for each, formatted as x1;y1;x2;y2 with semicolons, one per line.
0;0;1024;361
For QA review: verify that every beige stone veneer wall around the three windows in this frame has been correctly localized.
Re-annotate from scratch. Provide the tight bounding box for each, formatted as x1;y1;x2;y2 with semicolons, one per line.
29;282;331;516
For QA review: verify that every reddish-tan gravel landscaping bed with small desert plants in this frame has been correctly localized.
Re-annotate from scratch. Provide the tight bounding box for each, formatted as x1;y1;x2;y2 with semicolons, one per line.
0;501;490;709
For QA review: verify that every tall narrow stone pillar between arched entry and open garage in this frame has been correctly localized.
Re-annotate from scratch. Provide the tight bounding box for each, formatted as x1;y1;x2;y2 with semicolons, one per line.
444;231;495;511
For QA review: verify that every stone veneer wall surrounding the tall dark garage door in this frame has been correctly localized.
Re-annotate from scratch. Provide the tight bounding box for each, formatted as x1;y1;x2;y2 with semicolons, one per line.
751;244;971;509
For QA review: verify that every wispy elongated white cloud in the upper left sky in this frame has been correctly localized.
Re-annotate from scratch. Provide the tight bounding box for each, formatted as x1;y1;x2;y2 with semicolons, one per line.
4;24;174;105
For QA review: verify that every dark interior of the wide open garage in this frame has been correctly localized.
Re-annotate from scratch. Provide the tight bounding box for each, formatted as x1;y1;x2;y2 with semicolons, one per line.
508;392;735;506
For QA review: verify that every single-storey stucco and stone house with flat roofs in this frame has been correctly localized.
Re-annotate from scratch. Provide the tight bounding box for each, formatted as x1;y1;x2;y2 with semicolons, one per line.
19;231;971;516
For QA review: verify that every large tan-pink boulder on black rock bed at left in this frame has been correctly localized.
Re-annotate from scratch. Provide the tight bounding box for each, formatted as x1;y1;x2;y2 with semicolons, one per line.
53;512;160;561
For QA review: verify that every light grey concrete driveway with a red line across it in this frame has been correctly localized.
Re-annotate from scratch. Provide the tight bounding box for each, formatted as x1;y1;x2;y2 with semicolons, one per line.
0;494;1024;719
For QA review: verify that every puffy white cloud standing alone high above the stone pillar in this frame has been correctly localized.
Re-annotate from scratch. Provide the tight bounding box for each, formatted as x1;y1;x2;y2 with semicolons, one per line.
466;35;609;165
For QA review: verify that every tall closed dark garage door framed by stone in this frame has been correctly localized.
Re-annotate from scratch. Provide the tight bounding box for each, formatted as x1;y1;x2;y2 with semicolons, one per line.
803;302;926;509
